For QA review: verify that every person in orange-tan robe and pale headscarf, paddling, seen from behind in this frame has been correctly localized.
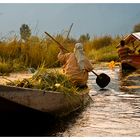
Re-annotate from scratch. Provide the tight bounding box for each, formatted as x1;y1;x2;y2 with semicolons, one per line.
58;43;93;88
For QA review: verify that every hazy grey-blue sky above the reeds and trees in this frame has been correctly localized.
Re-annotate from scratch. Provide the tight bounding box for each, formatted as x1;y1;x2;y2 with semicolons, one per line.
0;3;140;38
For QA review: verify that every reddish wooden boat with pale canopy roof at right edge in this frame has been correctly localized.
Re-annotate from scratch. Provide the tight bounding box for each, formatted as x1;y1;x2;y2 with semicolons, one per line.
117;32;140;72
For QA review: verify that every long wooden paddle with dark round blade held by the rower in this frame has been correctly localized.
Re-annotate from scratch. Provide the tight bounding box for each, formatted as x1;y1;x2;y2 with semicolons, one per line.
45;32;110;88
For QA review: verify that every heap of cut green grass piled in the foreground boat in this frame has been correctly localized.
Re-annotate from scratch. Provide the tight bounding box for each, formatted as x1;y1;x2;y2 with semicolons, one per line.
7;68;78;93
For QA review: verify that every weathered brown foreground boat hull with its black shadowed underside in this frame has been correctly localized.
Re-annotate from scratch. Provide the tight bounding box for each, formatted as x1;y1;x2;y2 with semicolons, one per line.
0;85;91;136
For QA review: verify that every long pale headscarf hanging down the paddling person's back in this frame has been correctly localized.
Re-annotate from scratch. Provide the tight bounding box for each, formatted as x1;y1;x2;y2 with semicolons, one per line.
74;43;84;70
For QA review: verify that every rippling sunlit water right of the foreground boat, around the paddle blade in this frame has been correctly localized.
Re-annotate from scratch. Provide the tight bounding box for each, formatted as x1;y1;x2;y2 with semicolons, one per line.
51;68;140;137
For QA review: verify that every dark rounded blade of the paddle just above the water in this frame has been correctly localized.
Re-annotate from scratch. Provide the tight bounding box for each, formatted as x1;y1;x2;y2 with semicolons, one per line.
96;73;110;88
